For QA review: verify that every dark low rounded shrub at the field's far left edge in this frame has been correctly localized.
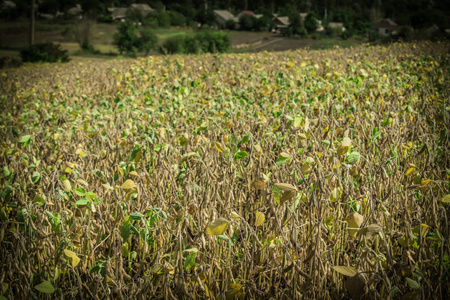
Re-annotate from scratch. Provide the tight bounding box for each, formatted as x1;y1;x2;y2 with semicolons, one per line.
20;43;70;62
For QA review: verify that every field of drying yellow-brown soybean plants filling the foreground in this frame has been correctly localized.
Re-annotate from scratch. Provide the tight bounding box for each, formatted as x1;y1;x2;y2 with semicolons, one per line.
0;42;450;299
